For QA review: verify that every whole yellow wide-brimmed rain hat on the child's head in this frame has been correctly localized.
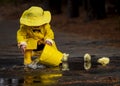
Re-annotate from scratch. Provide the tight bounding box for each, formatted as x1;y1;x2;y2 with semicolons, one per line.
20;6;51;26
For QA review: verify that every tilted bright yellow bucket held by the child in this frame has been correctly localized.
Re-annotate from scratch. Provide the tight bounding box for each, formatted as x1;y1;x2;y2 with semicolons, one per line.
39;44;63;66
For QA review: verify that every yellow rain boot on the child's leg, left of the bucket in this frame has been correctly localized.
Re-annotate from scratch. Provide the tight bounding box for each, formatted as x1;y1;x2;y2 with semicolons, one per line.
24;50;32;65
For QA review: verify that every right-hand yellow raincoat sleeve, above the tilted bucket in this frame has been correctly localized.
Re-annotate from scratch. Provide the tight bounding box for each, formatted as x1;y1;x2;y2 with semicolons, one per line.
44;24;54;43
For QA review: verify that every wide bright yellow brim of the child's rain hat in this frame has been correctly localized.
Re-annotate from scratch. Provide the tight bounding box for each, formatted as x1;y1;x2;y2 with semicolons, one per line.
20;11;51;26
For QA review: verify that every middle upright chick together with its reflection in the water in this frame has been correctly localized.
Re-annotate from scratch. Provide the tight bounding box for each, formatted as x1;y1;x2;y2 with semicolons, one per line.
84;53;91;70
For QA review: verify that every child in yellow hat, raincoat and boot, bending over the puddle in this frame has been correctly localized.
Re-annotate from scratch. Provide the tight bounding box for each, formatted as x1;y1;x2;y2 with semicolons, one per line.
17;6;66;67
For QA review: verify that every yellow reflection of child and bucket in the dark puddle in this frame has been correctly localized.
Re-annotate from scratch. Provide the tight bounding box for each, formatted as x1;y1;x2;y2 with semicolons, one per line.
24;74;62;86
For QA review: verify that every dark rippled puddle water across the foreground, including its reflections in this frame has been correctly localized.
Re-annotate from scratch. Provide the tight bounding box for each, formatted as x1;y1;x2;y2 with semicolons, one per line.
0;57;120;86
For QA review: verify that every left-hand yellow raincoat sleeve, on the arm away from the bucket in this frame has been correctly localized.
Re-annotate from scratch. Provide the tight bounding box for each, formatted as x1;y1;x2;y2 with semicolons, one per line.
17;25;27;47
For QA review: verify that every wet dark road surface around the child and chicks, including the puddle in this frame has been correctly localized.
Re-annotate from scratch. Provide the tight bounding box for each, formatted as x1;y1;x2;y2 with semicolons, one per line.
0;20;120;86
